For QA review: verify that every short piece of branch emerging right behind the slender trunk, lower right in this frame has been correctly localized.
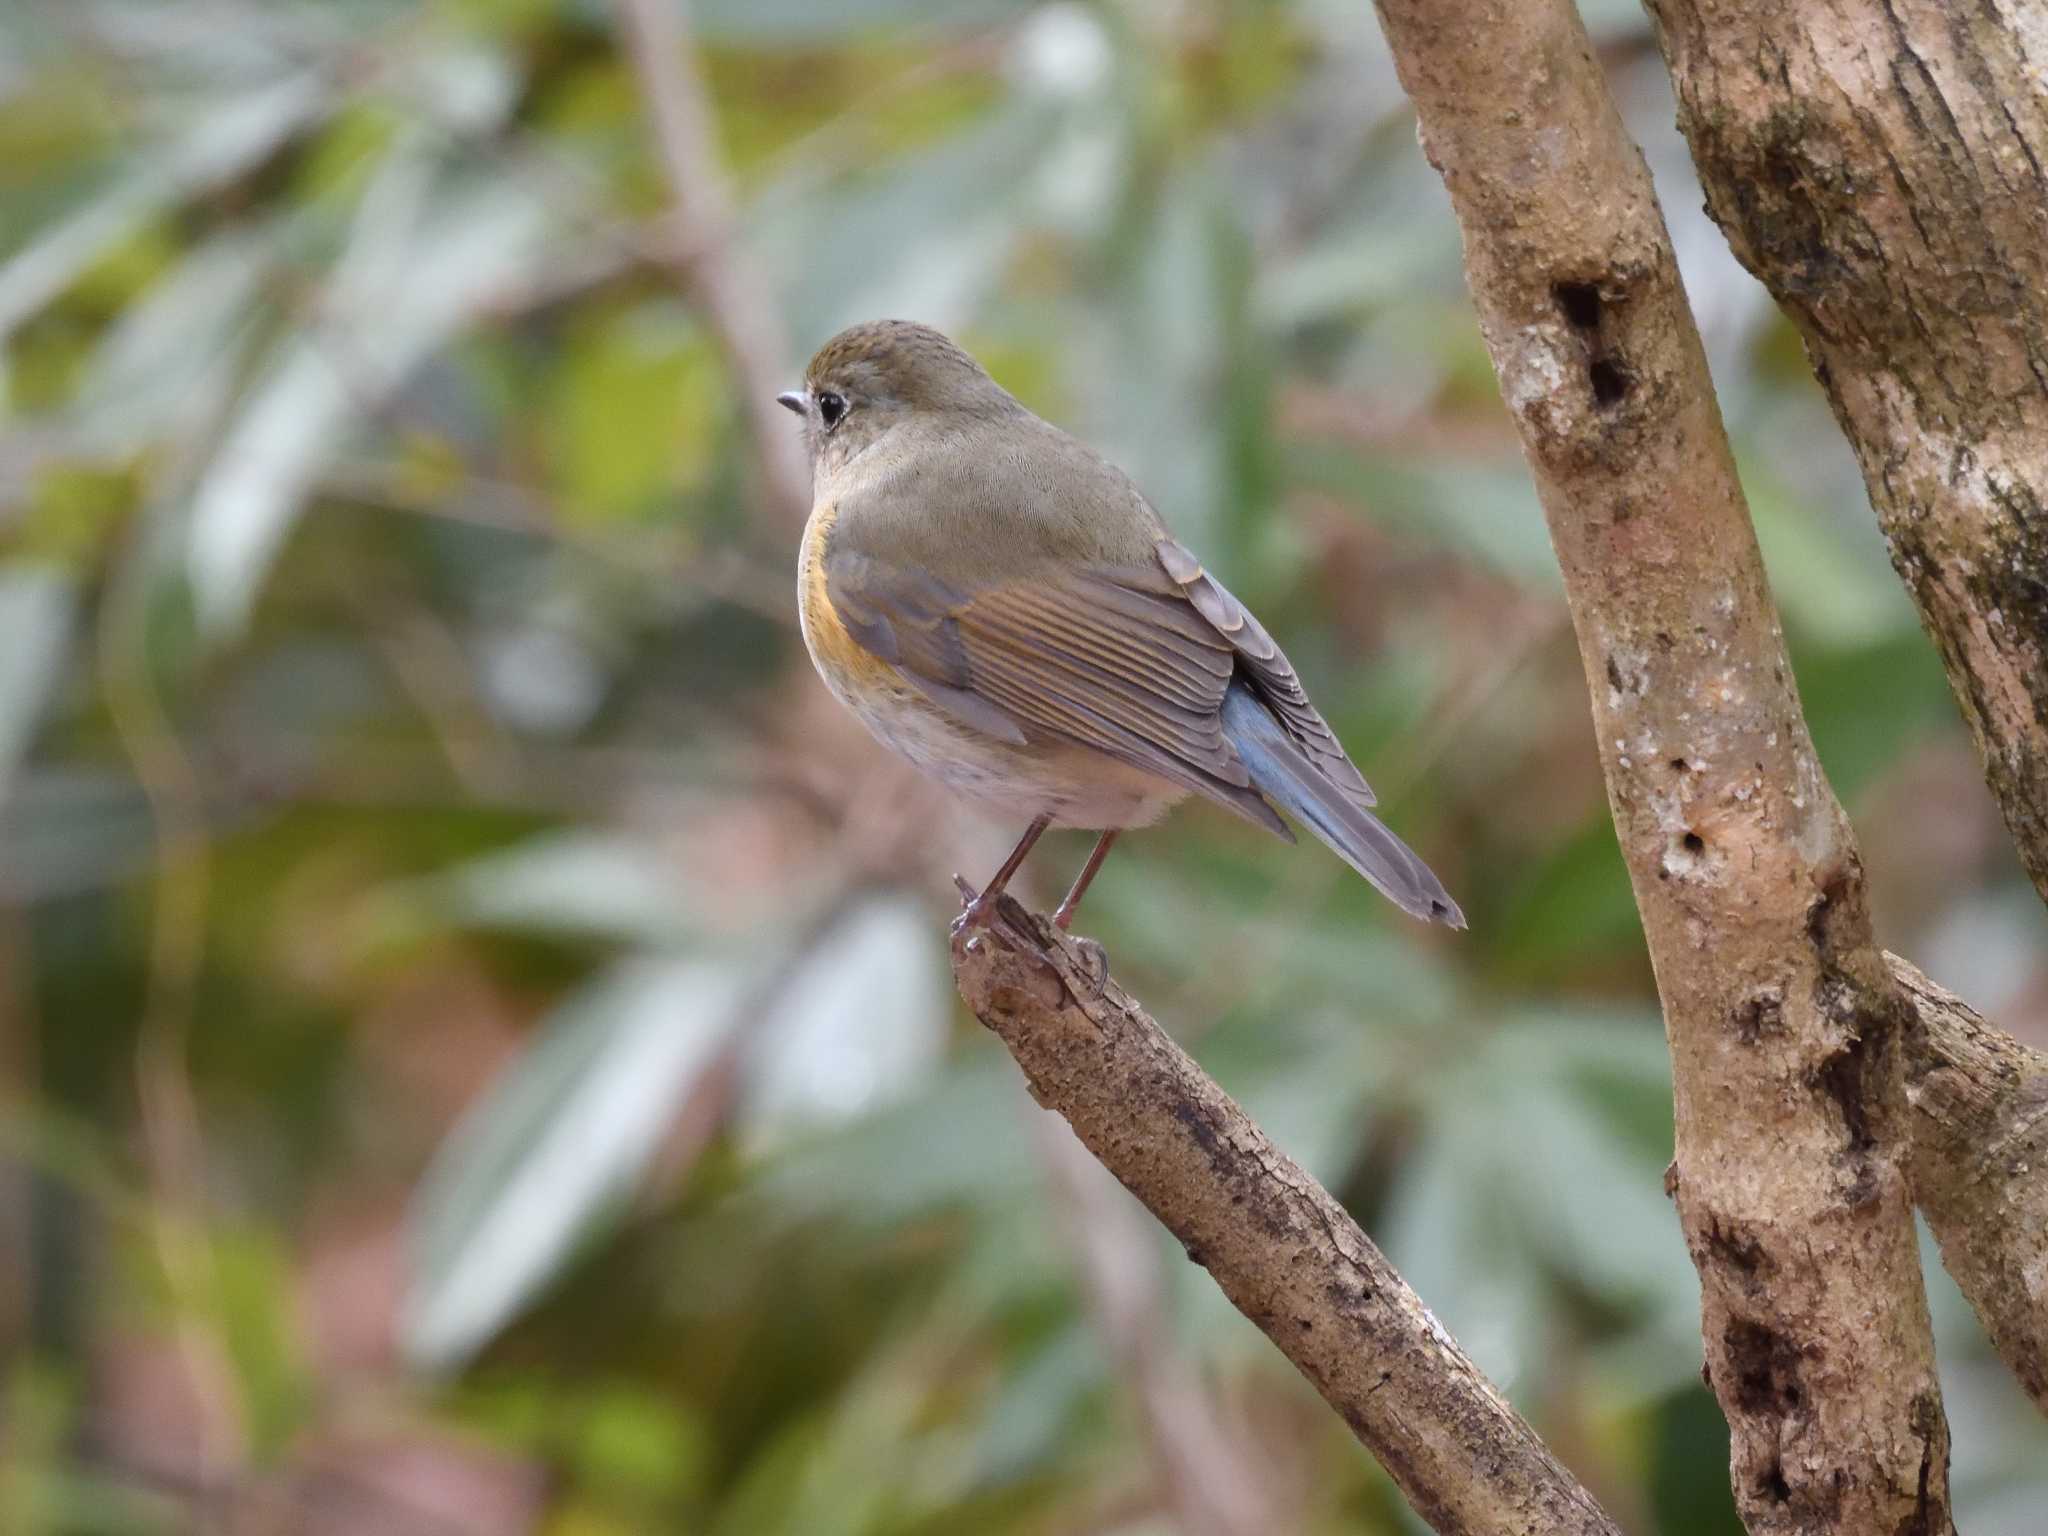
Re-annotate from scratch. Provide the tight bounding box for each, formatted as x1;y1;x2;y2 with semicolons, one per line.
1884;954;2048;1413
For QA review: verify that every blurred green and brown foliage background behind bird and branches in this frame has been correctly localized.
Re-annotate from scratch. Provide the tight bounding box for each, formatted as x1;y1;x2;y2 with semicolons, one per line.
0;0;2048;1536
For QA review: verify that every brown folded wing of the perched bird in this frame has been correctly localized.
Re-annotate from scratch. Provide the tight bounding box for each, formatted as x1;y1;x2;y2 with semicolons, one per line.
825;549;1292;838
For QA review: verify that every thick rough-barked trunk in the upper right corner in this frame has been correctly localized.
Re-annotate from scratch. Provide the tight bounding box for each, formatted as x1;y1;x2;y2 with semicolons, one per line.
1649;0;2048;899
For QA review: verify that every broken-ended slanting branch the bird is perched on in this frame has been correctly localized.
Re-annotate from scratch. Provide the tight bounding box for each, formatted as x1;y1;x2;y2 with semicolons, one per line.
952;897;1618;1536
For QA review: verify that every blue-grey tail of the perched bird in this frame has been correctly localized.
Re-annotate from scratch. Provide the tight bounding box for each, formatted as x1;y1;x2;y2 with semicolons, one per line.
1223;678;1464;928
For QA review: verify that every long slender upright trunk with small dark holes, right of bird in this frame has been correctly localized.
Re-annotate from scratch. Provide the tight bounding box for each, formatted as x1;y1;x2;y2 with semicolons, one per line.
1378;0;1950;1536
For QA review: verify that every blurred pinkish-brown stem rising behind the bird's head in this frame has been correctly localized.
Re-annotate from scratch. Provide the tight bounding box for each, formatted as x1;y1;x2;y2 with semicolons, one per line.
616;0;811;530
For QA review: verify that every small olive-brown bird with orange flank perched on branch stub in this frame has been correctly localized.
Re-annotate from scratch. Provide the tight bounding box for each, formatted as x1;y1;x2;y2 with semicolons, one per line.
776;319;1464;934
